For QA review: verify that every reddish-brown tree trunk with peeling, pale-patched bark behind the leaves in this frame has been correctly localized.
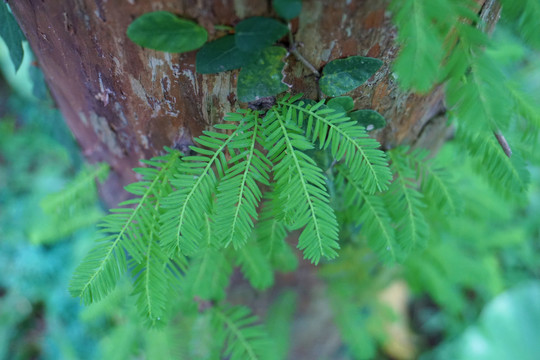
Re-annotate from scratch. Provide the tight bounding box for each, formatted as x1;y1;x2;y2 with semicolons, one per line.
10;0;493;358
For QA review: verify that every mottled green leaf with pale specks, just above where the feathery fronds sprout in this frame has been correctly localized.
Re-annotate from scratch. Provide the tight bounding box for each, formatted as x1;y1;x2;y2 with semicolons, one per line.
237;46;288;102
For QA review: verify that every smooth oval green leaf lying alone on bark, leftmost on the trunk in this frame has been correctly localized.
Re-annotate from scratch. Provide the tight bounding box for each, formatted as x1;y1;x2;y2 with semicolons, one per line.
127;11;208;53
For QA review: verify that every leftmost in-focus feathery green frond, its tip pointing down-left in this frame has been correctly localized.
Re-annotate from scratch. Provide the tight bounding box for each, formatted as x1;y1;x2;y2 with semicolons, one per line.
69;151;180;304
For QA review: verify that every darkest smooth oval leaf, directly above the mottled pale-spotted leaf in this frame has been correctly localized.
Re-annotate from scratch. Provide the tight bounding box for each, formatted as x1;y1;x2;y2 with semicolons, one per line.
235;16;289;52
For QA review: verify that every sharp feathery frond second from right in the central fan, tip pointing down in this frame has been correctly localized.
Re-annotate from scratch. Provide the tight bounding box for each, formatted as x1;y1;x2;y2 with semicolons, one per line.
264;107;339;264
